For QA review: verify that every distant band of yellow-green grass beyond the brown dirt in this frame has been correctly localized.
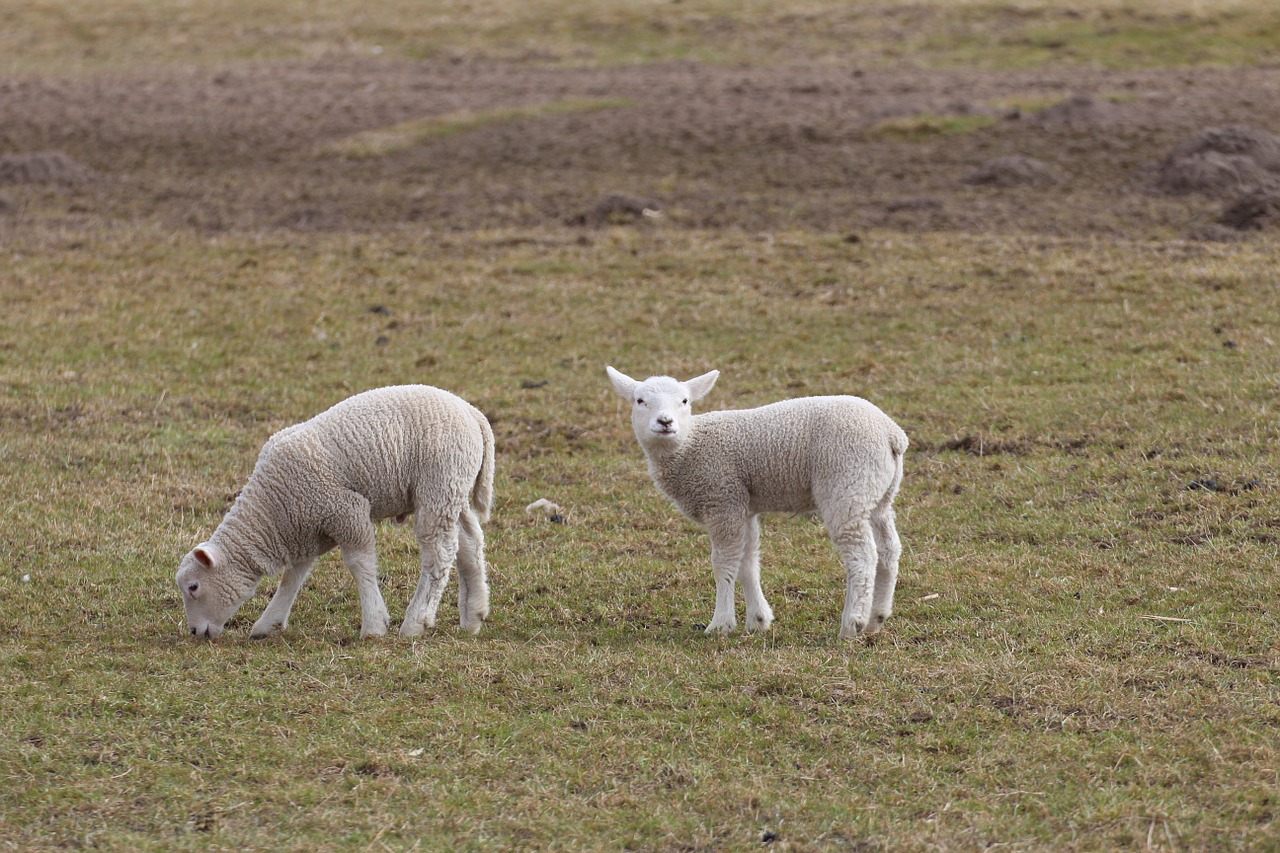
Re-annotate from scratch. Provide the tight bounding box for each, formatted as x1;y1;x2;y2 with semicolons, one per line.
0;0;1280;74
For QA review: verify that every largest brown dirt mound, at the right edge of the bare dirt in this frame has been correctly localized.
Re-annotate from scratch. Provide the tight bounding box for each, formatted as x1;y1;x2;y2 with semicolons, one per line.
1156;127;1280;196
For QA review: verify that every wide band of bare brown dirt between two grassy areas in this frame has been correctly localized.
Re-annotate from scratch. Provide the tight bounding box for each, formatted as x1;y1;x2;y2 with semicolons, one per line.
0;59;1280;238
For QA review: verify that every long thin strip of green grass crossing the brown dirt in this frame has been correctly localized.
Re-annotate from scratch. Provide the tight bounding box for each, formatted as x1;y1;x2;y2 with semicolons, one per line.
321;97;631;160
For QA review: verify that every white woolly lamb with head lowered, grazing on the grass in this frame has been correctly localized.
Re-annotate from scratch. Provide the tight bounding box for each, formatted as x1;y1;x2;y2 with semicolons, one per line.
177;386;493;638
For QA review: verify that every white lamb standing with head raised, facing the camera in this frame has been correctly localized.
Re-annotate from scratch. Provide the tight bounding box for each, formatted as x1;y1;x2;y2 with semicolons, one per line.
607;368;906;639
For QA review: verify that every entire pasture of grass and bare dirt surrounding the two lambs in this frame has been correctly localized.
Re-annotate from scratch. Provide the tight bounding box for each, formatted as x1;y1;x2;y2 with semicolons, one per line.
0;0;1280;852
